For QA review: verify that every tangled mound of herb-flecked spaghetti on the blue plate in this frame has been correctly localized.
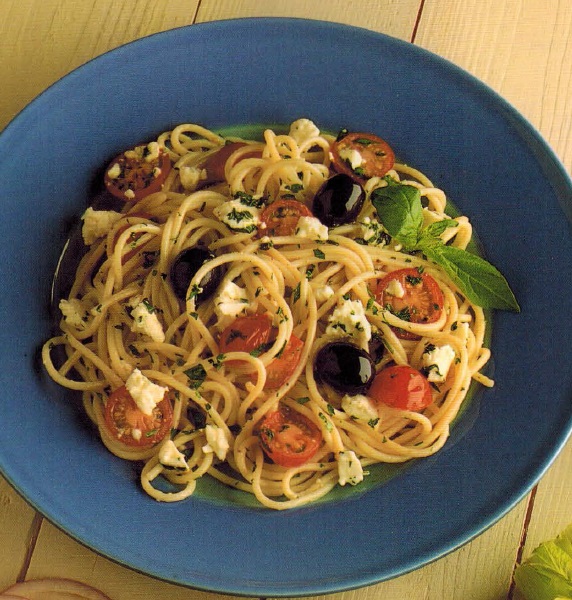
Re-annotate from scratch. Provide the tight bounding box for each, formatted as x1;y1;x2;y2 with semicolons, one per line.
43;119;493;509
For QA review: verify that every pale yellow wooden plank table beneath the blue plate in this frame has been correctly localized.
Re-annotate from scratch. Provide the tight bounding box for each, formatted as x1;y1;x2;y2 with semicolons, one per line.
0;0;572;600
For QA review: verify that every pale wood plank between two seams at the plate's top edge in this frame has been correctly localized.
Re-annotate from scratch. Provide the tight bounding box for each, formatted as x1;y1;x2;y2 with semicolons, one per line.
197;0;421;43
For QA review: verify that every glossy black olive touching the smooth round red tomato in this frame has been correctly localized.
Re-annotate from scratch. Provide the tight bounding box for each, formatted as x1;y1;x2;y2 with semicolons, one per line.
314;341;375;395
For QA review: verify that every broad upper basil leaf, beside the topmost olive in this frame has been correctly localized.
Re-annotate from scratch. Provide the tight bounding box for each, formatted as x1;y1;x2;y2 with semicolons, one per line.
371;184;423;250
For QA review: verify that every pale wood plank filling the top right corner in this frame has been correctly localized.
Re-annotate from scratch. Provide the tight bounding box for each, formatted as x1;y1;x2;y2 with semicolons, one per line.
416;0;572;173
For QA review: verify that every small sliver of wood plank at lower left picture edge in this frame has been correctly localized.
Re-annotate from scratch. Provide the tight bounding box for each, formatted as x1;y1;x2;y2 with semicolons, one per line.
0;475;37;590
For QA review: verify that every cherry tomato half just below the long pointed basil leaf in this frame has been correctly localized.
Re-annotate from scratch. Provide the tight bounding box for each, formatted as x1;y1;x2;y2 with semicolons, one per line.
375;268;444;340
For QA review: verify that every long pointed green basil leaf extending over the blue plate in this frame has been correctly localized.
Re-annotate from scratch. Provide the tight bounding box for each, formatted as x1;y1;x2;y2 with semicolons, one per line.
420;242;520;312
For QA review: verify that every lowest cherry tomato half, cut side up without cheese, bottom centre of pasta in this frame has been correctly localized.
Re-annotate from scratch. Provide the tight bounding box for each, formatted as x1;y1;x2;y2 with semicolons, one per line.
258;405;322;467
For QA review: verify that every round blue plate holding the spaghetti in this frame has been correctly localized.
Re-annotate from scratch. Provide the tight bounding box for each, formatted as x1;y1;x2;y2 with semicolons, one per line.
0;19;572;596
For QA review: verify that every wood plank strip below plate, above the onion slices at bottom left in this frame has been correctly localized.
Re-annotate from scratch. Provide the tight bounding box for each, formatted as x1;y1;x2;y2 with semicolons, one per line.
27;521;250;600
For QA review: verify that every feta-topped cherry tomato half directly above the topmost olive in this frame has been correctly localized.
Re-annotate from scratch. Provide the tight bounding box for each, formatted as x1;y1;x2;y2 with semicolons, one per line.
331;133;395;183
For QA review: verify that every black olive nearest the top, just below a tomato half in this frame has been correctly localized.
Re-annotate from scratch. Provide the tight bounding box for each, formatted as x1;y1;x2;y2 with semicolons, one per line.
312;173;365;227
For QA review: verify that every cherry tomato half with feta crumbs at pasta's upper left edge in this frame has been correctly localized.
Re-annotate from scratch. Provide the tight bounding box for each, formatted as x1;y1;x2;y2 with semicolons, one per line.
103;145;171;202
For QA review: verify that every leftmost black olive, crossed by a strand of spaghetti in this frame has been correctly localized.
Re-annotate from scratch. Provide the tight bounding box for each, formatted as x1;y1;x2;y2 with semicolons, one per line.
171;247;224;302
